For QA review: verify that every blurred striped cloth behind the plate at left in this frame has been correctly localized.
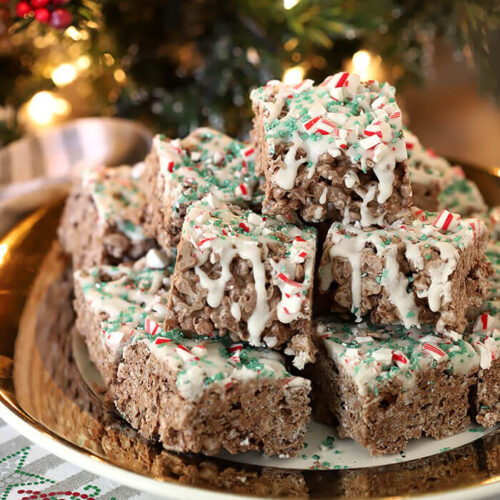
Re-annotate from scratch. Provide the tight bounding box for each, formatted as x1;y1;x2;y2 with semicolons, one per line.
0;118;152;235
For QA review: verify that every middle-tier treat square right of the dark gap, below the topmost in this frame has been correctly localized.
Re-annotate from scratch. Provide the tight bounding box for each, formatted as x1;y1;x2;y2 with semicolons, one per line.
319;210;491;333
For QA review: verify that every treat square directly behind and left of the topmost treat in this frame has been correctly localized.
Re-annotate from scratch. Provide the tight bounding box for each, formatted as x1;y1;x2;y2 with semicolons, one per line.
142;128;262;248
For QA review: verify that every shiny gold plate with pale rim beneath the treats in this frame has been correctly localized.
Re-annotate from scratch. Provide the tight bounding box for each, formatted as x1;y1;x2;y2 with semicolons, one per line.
0;163;500;499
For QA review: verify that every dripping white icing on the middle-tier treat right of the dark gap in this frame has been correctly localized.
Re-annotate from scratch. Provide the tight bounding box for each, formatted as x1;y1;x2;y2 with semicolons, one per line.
320;209;485;330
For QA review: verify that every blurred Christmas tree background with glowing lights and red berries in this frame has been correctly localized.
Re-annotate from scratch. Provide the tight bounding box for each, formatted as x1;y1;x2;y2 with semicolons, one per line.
0;0;500;168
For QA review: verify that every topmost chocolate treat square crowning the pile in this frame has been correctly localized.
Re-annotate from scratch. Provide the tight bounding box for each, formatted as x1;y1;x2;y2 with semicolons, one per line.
250;73;412;226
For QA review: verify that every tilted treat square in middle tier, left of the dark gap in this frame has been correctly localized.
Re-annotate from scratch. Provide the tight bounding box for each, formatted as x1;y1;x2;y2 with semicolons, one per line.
165;195;316;368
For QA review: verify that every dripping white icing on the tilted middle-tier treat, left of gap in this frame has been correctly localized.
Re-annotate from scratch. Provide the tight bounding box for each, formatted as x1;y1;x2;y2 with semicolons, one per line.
183;195;316;345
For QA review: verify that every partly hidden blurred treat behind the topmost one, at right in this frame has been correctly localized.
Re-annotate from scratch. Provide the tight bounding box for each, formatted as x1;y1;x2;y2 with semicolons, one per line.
404;130;487;216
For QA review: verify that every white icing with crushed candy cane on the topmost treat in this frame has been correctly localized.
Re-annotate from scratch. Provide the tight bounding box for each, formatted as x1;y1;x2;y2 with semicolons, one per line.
250;73;407;226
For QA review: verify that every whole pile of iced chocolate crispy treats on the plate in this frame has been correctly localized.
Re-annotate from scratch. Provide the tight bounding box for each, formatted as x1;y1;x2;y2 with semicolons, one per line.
59;73;500;458
